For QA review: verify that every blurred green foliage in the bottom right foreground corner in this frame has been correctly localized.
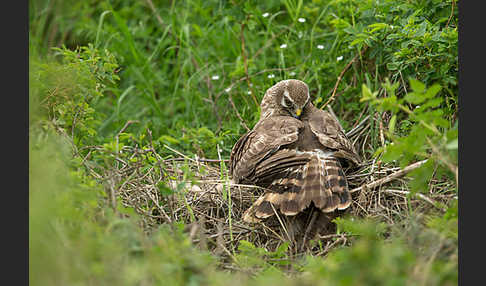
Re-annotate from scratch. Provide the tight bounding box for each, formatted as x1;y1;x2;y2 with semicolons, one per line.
303;218;457;285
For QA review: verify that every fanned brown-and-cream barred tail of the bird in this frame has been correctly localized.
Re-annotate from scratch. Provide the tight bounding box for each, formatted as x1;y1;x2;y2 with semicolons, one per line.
243;153;351;222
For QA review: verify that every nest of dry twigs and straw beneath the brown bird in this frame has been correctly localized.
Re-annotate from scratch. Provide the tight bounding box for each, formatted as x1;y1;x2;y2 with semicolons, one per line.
94;114;455;264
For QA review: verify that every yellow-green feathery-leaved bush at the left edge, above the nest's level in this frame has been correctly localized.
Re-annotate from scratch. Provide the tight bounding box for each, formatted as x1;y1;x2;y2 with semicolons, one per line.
30;44;120;147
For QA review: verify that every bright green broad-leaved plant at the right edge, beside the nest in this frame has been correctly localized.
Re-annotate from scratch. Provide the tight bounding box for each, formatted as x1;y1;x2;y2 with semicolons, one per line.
361;79;458;191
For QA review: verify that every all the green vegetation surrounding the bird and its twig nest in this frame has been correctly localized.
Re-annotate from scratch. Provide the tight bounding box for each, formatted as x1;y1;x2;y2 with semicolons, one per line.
29;0;458;285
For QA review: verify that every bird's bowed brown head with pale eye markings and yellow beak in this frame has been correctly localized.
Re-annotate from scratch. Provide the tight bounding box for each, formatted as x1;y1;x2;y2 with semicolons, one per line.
277;79;310;119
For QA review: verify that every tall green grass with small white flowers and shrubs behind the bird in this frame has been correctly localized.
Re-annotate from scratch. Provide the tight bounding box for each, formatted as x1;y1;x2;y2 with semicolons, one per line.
30;0;457;154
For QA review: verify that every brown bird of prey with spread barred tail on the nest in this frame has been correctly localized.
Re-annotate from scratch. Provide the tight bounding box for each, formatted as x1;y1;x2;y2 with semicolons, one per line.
230;79;361;222
